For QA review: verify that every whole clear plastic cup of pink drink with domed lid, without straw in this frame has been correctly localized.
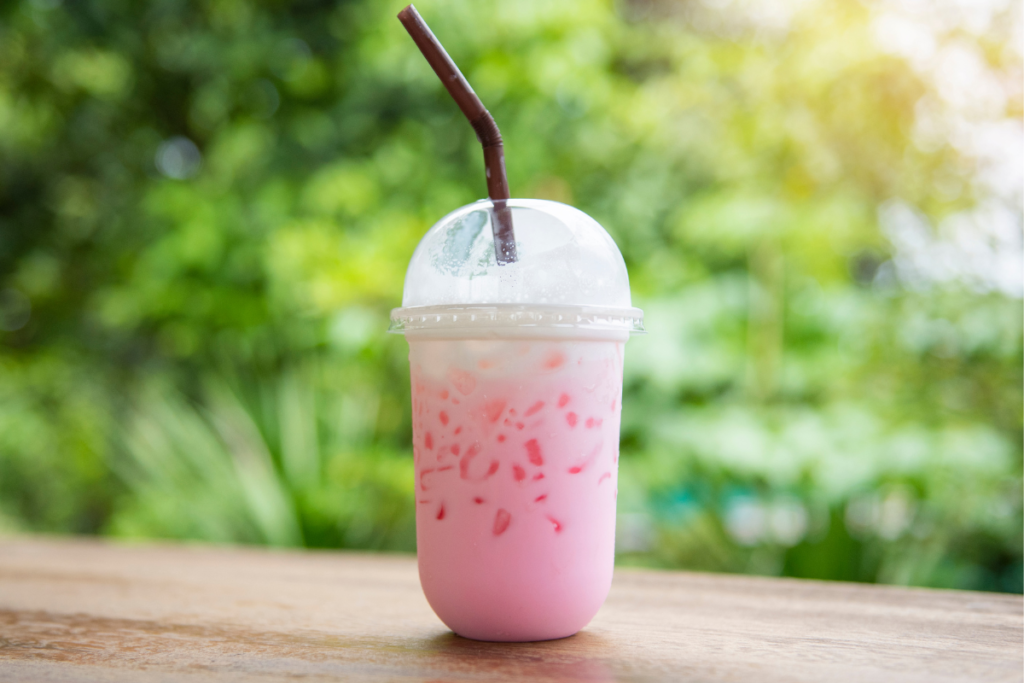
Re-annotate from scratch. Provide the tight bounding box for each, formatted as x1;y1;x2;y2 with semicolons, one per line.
391;200;643;641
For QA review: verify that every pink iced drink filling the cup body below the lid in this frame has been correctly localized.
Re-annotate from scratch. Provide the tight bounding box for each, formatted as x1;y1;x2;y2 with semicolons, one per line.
409;338;624;641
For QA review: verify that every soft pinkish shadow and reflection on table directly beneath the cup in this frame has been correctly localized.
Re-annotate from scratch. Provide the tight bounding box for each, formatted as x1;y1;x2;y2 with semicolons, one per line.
423;631;617;681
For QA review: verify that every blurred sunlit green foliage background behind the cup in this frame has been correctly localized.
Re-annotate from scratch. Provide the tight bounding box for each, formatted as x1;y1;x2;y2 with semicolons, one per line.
0;0;1024;592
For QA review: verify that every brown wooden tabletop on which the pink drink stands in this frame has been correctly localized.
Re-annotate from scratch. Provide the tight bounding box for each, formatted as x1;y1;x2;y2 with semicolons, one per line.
0;538;1024;683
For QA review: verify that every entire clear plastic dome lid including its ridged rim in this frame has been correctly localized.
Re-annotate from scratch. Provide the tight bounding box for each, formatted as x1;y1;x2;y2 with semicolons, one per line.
391;199;643;334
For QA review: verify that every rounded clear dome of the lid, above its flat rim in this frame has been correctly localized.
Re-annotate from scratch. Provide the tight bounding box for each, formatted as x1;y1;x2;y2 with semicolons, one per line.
402;200;632;308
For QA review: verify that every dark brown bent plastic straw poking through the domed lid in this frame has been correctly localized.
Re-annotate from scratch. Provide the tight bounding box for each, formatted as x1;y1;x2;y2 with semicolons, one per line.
398;5;516;265
